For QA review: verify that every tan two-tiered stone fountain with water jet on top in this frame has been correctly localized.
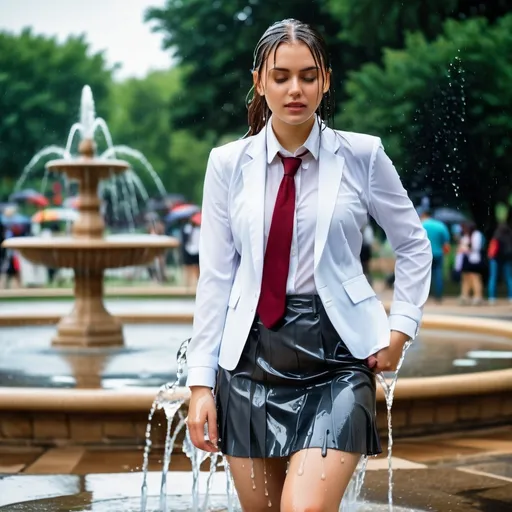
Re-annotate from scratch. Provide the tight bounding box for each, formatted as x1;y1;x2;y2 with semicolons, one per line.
3;86;178;347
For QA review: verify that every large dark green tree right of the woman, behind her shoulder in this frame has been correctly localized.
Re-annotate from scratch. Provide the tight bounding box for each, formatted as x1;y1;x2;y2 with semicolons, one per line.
339;15;512;230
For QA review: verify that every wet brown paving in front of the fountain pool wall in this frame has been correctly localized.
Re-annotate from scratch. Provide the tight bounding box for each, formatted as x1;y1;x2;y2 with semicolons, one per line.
0;427;512;512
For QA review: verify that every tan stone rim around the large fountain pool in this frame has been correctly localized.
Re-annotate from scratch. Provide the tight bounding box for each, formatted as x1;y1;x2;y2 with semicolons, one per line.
0;314;512;413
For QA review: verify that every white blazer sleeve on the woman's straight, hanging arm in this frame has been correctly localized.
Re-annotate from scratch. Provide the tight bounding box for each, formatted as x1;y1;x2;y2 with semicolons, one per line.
187;149;237;388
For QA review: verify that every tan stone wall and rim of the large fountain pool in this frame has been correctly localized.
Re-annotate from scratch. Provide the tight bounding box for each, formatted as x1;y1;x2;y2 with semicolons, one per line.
0;306;512;447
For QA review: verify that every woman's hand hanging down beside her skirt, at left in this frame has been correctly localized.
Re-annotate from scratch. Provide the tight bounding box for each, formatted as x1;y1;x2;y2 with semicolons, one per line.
187;386;219;453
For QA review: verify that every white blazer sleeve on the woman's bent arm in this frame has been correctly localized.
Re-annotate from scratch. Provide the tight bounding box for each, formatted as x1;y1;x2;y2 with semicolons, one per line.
369;139;432;339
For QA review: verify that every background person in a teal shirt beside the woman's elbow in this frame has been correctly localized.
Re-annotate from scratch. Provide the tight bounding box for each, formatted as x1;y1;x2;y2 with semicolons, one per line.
421;209;450;302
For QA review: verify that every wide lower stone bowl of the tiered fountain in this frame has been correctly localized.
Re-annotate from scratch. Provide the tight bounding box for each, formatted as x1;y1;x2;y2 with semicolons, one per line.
3;235;179;272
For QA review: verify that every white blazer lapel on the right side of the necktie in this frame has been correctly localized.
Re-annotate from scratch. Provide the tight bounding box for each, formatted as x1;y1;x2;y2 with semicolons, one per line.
314;128;345;269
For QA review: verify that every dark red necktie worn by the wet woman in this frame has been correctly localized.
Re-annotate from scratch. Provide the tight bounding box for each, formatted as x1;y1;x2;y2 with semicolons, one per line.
258;151;307;329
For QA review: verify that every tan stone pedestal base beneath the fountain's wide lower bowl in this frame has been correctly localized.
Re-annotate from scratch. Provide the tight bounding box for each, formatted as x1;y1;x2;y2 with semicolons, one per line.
53;269;123;347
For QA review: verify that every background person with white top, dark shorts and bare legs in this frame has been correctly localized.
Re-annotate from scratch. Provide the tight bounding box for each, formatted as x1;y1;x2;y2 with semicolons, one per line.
457;222;484;306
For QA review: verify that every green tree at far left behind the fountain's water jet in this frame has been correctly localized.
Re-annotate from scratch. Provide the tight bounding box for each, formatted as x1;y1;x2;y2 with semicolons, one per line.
0;30;112;189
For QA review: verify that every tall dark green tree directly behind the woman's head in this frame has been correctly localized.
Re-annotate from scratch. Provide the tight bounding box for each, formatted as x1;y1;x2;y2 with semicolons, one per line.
146;0;352;136
